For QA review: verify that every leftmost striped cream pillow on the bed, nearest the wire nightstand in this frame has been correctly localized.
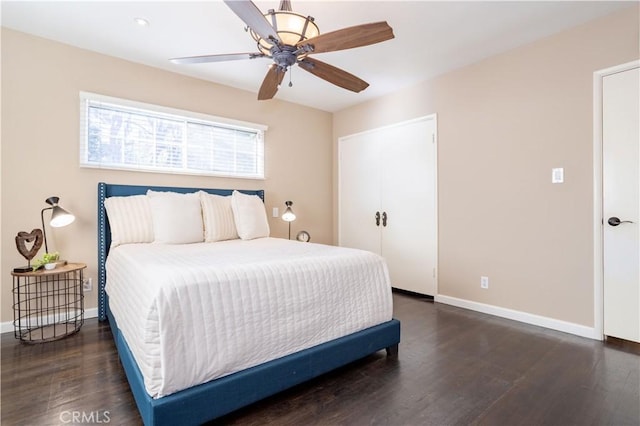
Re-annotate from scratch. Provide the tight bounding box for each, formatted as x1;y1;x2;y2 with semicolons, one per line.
104;195;153;248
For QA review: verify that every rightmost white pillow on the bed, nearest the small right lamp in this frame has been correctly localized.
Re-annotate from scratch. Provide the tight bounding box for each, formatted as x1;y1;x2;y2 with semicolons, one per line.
231;191;270;240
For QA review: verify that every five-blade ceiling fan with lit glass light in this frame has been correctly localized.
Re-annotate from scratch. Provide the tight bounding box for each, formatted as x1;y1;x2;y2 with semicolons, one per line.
170;0;394;100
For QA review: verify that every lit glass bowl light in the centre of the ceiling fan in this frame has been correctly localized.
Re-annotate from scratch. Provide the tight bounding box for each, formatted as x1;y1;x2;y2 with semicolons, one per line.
250;9;320;56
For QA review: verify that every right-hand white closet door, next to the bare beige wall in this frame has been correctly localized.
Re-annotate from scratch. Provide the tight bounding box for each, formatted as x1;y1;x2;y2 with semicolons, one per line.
380;119;436;296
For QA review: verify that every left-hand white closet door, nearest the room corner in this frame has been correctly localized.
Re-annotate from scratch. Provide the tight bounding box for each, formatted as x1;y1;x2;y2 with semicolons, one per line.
338;133;381;253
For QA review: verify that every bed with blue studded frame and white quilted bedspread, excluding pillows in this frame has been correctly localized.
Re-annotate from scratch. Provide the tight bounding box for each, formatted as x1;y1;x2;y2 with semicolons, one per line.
98;183;400;425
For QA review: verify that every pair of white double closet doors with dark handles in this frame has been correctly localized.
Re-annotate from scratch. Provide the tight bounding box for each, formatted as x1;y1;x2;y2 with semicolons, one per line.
338;116;437;295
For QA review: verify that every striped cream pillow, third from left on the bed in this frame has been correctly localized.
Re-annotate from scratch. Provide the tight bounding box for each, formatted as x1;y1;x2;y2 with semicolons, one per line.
200;191;238;243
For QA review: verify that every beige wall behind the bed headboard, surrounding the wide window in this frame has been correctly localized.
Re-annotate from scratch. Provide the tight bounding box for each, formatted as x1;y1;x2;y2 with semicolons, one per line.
0;29;333;322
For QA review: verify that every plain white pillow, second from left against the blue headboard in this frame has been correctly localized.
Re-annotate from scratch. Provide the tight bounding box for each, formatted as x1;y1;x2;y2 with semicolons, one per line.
147;190;204;244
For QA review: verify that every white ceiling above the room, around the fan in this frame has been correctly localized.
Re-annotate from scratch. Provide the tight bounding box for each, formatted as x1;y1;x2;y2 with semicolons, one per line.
1;0;636;111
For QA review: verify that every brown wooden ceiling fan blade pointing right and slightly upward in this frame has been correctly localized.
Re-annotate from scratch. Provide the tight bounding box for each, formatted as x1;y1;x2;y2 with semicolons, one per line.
296;22;394;53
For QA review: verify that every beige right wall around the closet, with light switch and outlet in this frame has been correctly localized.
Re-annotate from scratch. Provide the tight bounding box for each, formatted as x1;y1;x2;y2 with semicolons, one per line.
334;7;639;326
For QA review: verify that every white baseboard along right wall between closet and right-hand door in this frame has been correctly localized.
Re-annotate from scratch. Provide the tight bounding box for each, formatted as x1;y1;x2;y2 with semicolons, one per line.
434;295;603;340
